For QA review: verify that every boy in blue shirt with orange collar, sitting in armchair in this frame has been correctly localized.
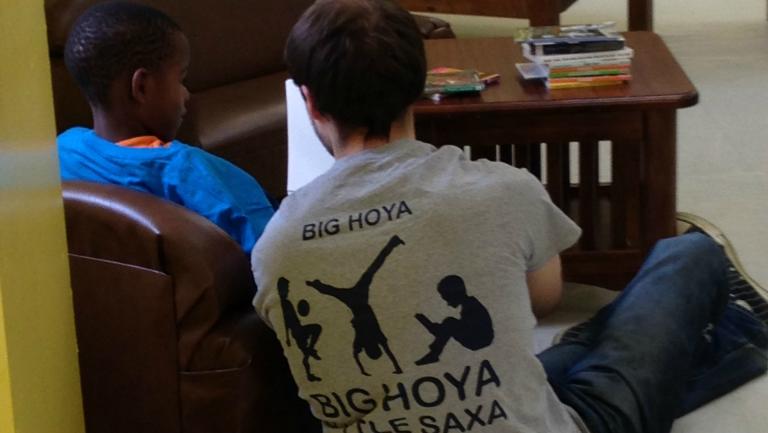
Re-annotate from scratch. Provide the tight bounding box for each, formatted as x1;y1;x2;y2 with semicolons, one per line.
58;2;274;253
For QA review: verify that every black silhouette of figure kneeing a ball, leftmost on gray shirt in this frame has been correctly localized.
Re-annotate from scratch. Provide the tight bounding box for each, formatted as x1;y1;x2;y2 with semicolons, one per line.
277;277;323;382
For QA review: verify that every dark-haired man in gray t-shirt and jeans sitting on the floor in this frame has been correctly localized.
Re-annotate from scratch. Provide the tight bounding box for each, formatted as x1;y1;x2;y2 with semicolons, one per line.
252;0;768;433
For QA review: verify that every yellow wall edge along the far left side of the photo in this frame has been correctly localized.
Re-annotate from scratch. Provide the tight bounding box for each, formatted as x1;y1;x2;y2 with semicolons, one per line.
0;0;84;433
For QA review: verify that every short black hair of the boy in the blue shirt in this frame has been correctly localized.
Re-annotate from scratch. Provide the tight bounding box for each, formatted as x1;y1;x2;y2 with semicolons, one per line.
64;2;181;107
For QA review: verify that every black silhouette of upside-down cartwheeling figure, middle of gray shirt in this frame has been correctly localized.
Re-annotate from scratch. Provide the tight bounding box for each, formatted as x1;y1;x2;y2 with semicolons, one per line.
307;235;405;376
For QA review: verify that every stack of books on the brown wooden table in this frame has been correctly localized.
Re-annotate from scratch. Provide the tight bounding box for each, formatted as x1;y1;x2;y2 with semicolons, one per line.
516;24;633;89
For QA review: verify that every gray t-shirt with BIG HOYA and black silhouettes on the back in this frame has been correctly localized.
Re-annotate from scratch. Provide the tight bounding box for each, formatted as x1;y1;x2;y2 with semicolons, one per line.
253;140;580;433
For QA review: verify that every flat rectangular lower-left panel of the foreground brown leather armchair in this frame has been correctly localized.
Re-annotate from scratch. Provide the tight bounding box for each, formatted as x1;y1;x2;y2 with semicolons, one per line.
70;253;180;433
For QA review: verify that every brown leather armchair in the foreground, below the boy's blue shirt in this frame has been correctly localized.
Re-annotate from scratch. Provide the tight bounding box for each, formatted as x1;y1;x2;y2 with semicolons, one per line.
63;182;320;433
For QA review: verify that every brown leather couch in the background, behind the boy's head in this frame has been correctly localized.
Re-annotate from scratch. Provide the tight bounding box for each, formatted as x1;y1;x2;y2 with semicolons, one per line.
45;0;453;198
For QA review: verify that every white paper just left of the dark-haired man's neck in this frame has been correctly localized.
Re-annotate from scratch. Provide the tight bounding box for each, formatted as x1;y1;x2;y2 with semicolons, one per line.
285;80;333;194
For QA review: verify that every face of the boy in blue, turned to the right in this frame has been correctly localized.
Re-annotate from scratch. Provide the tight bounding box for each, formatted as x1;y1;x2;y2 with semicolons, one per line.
142;32;190;141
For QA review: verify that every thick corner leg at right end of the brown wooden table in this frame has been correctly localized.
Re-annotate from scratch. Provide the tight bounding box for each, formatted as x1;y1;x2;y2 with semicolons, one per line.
642;109;677;250
